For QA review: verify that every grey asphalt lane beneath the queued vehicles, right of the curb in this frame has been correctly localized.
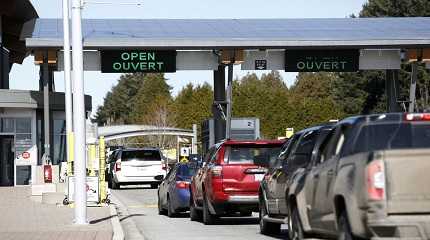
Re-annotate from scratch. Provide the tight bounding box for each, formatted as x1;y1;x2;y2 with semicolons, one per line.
111;186;287;240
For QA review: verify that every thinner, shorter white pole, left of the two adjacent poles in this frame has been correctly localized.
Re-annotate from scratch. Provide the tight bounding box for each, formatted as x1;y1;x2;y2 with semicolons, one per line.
63;0;73;176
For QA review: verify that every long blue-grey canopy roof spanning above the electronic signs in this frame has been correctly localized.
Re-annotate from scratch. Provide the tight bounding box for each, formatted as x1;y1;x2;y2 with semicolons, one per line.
21;17;430;50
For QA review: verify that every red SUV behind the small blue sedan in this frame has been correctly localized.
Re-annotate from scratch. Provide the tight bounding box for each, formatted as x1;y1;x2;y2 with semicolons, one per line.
190;140;283;224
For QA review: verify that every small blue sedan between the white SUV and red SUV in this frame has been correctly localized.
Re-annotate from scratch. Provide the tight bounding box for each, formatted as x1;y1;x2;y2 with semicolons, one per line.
158;163;197;217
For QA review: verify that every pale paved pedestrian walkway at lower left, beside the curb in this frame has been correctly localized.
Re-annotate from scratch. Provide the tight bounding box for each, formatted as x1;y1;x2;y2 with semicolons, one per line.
0;187;113;240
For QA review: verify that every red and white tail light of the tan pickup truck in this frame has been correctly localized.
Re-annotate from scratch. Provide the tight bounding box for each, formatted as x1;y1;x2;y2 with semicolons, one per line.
367;160;385;201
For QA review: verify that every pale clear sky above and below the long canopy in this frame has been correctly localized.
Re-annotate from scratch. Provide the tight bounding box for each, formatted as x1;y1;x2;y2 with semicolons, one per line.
10;0;366;113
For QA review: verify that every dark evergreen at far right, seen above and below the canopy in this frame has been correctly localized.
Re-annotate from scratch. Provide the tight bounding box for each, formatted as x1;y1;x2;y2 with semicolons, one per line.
334;0;430;115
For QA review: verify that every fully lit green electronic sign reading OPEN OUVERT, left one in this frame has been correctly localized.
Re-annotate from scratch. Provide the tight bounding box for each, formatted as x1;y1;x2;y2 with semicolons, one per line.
101;50;176;73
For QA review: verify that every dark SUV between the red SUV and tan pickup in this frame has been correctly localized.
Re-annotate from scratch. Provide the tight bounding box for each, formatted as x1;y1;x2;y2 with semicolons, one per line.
259;125;332;234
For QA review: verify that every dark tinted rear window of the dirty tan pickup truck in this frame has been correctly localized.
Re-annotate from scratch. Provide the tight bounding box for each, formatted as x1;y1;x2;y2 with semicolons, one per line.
355;123;430;152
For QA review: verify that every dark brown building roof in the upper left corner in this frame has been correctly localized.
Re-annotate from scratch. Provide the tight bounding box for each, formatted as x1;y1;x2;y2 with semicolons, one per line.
0;0;38;64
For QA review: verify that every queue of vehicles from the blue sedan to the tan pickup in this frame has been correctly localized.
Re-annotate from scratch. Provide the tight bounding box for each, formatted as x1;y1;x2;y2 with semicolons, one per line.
111;113;430;239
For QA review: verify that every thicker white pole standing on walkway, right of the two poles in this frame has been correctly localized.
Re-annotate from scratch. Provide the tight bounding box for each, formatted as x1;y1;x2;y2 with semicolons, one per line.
72;0;87;225
